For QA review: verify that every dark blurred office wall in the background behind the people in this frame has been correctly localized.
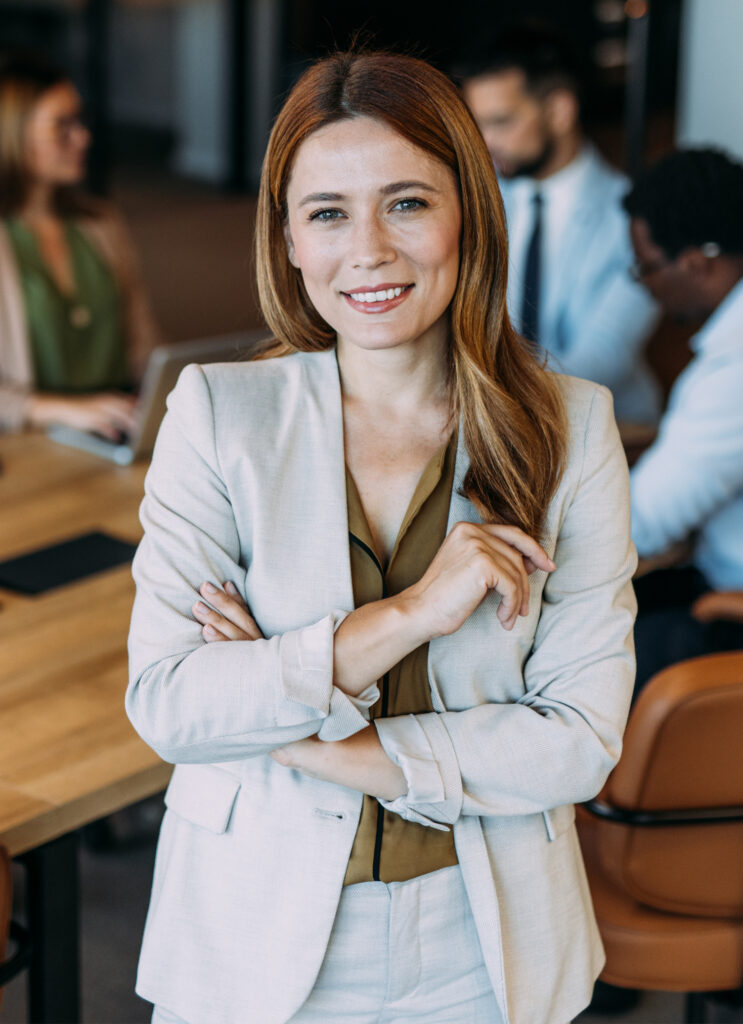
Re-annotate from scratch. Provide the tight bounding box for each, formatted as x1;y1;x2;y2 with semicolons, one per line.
0;0;743;358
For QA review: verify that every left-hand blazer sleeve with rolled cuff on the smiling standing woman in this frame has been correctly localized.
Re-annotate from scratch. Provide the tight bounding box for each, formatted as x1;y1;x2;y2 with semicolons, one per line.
126;366;379;763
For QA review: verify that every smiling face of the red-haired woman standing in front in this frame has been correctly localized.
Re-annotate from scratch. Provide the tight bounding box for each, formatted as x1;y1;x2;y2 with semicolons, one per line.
286;117;462;350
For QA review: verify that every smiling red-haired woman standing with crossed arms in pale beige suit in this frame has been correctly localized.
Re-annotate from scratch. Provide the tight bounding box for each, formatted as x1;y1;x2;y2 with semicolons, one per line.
127;53;636;1024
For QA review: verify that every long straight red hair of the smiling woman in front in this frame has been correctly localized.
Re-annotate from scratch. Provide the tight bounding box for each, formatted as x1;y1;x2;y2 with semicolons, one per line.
256;52;567;536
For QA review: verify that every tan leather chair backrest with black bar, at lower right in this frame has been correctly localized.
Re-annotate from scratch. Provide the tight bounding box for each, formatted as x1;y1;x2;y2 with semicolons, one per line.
599;651;743;919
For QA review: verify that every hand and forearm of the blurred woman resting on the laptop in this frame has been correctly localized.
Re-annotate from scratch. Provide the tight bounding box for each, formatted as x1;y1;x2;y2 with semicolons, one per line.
28;391;137;440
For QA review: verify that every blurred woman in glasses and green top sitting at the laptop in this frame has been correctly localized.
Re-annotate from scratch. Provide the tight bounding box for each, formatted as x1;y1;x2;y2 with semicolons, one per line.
0;57;160;438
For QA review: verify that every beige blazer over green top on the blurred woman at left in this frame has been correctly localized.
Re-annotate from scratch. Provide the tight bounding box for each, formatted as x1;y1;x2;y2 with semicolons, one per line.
0;204;162;431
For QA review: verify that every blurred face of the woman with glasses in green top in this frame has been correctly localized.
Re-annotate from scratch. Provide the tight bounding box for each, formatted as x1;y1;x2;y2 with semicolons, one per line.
26;82;90;186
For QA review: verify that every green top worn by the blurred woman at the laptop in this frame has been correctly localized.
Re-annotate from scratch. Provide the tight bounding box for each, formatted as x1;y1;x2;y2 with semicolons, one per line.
5;218;131;393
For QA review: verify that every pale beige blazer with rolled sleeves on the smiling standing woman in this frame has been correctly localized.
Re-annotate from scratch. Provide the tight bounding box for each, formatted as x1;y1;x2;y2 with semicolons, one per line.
127;350;636;1024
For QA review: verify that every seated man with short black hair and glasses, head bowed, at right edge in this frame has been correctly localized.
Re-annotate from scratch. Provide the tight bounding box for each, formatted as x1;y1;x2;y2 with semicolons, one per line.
624;150;743;687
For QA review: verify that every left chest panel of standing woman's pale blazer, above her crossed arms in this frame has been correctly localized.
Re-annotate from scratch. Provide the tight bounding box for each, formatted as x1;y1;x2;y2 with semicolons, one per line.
235;351;353;635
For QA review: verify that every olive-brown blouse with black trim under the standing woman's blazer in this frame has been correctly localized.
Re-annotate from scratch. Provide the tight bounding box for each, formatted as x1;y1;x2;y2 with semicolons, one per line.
345;431;457;885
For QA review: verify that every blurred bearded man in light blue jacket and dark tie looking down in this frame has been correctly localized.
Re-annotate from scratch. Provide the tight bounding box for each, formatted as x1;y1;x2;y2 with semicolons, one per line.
456;26;660;425
